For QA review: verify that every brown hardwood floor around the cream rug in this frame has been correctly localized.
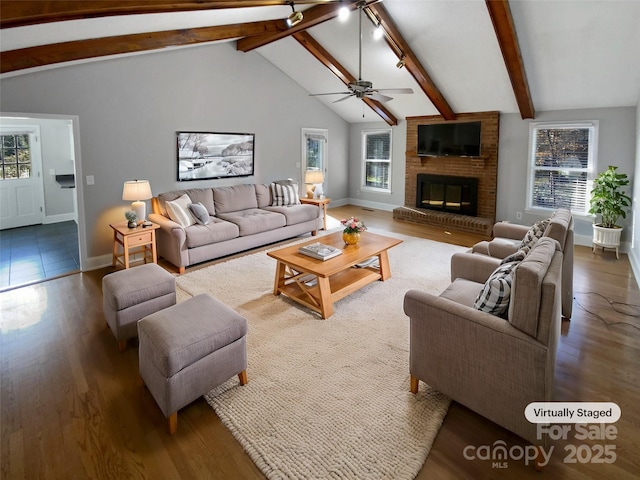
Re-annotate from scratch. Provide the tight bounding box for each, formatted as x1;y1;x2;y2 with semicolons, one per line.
0;206;640;480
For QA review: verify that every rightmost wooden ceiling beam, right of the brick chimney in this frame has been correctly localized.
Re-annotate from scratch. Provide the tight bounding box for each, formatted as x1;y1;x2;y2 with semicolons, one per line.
485;0;535;120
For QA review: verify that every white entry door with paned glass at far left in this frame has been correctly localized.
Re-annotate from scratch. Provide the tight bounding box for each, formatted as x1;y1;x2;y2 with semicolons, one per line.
0;125;44;230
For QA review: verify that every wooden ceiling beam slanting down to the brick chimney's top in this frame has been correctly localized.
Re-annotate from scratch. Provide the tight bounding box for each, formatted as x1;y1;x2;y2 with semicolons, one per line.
367;3;456;120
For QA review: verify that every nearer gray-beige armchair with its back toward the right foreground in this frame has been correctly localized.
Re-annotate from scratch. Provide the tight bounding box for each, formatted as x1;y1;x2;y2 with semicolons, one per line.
404;237;563;454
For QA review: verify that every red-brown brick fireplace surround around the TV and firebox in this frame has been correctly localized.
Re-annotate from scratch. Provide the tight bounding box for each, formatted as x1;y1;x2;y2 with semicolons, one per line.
393;112;500;238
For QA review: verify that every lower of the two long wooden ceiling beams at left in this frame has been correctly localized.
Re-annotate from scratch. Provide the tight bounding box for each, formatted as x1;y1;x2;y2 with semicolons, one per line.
0;20;281;73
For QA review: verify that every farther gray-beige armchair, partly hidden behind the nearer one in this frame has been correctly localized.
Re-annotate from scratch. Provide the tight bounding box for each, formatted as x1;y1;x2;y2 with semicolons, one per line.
471;208;574;319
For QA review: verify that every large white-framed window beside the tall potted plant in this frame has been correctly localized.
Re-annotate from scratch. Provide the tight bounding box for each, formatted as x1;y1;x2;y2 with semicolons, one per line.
527;121;598;215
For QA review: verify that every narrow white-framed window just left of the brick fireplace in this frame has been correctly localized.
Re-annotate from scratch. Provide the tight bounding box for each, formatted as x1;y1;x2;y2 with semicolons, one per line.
362;130;391;192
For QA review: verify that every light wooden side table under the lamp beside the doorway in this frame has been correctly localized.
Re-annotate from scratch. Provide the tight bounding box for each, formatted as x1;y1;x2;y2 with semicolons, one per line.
109;221;160;268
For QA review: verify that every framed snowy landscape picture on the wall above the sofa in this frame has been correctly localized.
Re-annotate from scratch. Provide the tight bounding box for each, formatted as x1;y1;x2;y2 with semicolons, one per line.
176;132;255;182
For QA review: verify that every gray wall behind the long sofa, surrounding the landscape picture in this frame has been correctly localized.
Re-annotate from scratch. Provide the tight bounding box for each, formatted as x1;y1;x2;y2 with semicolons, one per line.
0;43;348;268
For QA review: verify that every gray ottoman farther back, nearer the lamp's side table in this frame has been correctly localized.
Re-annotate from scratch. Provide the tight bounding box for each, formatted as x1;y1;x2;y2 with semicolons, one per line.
102;263;176;351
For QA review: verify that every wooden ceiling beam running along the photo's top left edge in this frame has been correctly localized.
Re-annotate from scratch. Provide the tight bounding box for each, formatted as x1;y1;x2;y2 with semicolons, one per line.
0;0;328;28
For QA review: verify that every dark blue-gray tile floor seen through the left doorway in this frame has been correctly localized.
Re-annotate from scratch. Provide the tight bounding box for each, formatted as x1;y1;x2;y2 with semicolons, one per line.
0;221;80;290
